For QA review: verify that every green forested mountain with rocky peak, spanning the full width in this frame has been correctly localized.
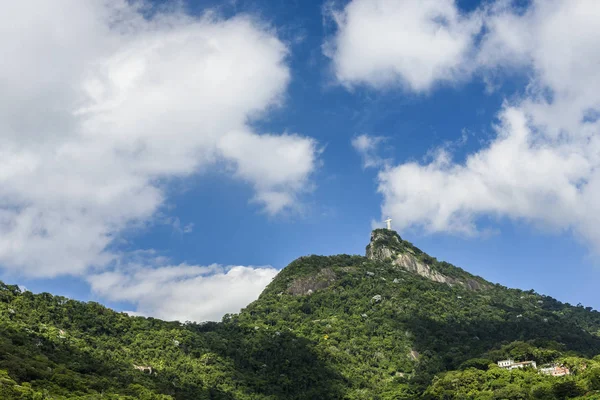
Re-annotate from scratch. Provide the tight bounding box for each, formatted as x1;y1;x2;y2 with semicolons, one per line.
0;229;600;400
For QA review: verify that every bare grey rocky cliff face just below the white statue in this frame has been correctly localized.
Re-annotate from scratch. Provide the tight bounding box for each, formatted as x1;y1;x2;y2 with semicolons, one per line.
366;229;489;290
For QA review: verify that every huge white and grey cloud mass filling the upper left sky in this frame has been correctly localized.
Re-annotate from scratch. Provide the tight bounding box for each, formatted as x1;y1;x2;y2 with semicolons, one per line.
0;0;318;279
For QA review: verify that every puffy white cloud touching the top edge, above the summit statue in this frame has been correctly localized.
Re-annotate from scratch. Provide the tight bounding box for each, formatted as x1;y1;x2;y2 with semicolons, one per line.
325;0;480;91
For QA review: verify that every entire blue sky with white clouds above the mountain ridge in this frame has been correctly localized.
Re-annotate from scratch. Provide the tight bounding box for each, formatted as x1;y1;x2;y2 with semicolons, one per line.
0;0;600;320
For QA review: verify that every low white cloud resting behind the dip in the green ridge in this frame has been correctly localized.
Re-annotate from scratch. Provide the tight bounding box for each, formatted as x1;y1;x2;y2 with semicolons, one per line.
88;264;278;322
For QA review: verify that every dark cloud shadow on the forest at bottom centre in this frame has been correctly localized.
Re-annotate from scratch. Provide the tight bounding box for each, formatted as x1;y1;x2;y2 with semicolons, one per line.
192;323;348;400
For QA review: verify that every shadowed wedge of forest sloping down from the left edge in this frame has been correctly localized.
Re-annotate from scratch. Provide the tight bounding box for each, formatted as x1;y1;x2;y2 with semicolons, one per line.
0;325;234;400
